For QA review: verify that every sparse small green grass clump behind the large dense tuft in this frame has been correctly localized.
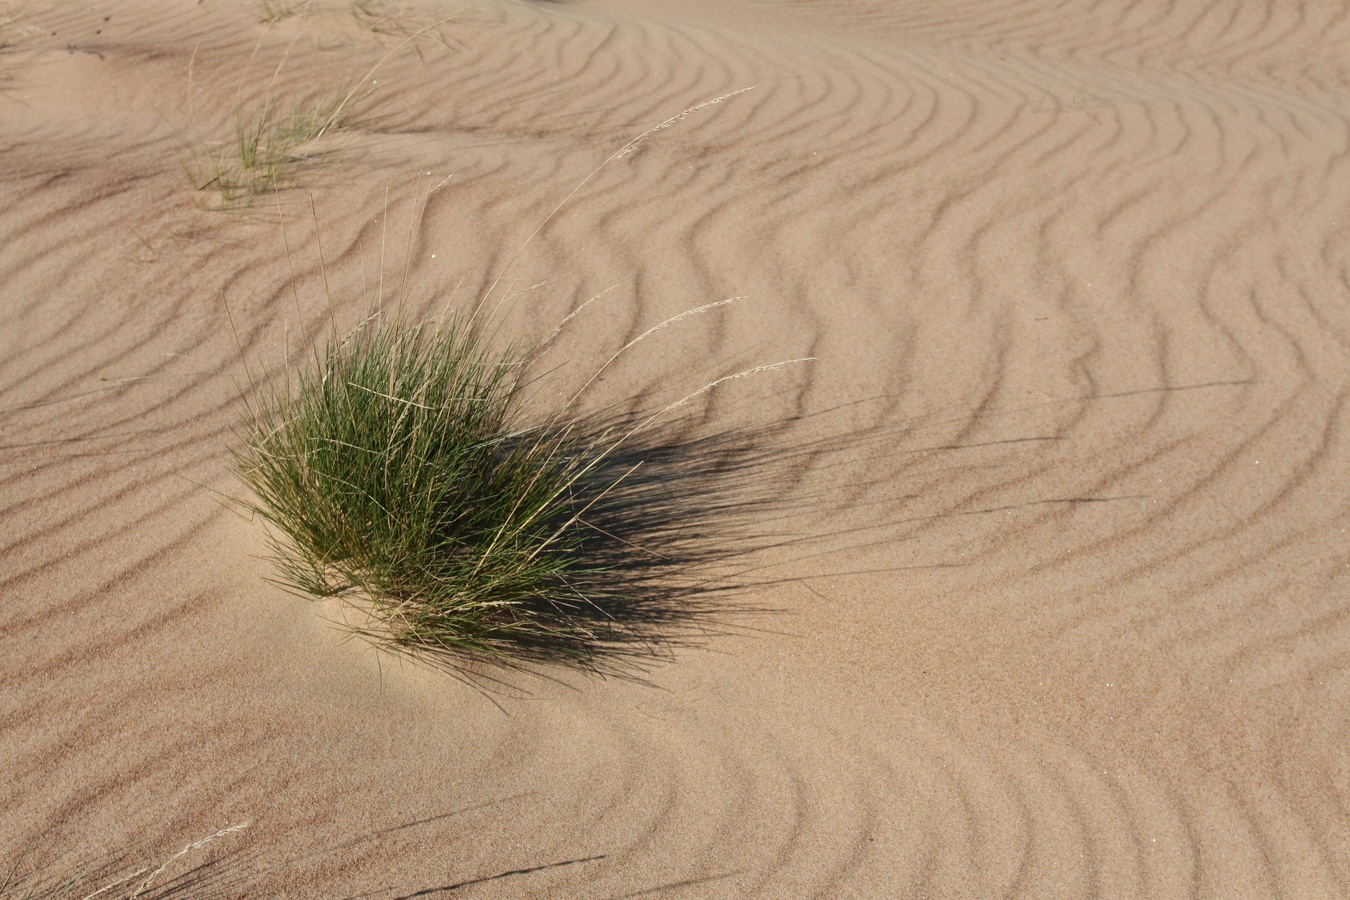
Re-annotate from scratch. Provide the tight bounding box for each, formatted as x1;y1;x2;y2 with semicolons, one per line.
188;89;369;206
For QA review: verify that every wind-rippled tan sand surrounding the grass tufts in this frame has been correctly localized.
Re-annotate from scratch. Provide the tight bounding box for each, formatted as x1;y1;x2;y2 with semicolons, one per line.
0;0;1350;899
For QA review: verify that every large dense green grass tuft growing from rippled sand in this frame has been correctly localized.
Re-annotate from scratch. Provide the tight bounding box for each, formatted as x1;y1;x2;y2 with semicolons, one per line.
236;316;626;668
